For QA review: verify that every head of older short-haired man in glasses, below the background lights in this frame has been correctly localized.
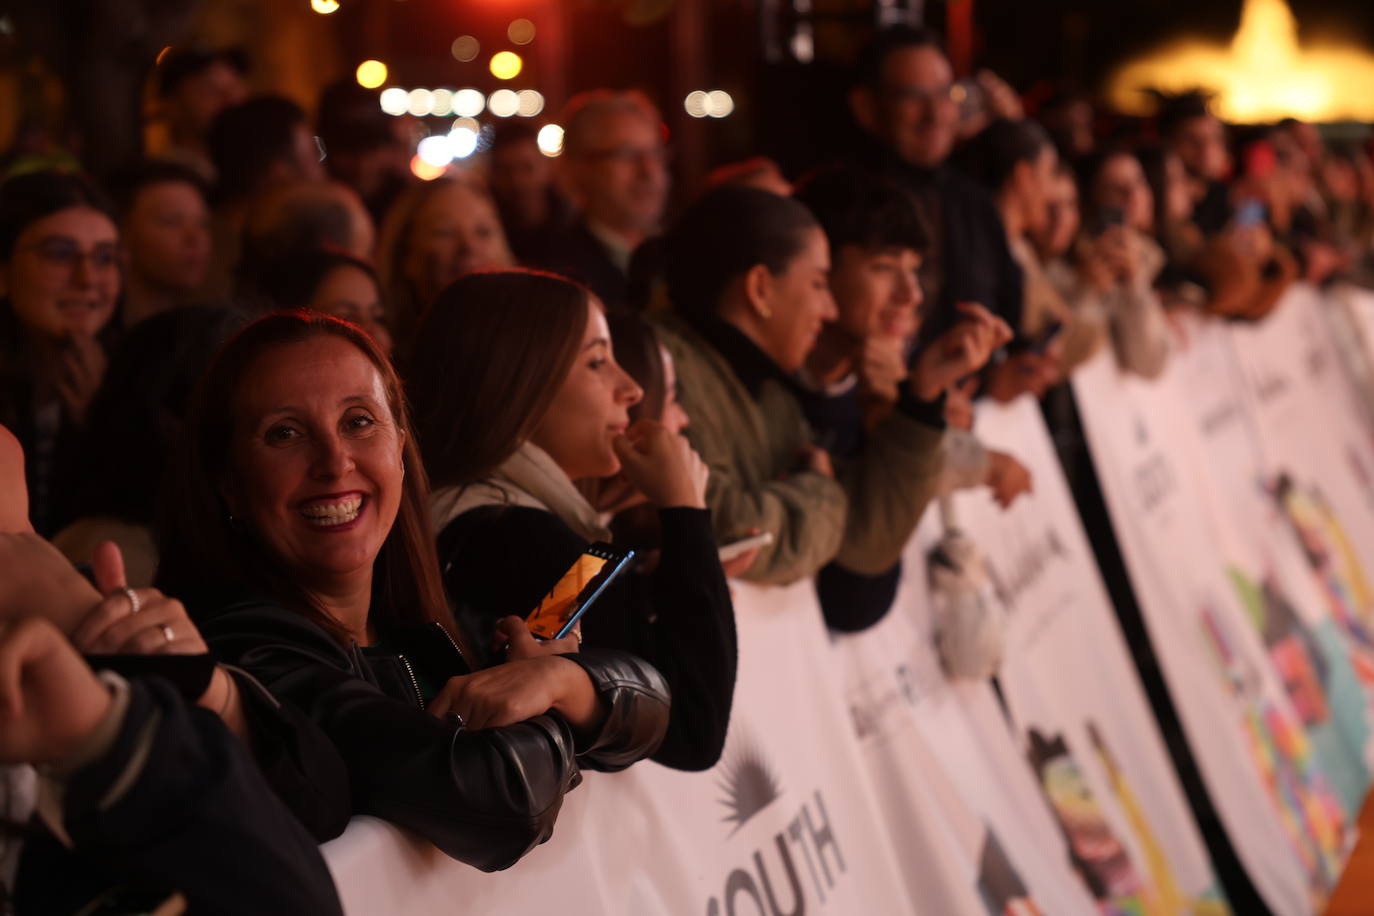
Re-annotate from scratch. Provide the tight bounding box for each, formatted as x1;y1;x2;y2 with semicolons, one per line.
530;89;669;306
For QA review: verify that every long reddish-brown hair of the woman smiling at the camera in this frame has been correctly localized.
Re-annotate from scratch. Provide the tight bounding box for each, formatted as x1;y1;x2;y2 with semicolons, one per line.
158;312;453;643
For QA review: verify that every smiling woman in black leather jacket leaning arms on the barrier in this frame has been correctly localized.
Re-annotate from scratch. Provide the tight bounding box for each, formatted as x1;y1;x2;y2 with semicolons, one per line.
159;312;668;871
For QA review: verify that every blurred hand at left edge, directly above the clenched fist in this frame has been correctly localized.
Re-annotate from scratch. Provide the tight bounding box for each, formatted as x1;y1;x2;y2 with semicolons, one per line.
0;531;100;632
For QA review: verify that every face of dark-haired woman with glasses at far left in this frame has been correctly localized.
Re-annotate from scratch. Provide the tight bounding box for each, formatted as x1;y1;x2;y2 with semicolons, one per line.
3;206;120;341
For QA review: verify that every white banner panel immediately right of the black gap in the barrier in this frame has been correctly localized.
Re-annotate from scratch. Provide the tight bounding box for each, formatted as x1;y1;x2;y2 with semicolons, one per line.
1073;339;1348;915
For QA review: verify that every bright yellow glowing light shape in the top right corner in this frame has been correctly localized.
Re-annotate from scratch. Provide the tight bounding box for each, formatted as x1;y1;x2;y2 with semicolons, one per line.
1107;0;1374;124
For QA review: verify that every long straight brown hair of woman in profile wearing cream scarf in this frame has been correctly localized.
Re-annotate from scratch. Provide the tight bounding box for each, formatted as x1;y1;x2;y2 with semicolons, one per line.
407;271;589;486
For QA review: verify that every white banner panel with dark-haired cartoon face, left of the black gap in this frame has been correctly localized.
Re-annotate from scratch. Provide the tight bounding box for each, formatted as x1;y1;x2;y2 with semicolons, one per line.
955;400;1228;916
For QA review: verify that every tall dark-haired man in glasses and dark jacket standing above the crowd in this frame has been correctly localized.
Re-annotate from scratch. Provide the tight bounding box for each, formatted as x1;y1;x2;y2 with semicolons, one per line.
849;26;1041;398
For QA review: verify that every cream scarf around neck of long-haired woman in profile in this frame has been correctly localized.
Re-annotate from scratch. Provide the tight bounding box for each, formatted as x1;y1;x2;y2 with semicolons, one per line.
430;442;610;541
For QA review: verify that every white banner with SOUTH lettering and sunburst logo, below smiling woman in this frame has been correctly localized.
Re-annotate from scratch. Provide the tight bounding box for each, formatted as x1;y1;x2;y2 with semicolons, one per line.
324;582;916;916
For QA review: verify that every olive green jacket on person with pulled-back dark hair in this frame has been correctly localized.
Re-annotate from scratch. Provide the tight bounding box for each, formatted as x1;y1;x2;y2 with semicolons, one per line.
655;316;943;584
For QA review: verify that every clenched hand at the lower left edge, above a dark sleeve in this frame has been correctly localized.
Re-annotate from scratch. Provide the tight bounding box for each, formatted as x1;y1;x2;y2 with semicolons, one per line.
0;617;110;764
